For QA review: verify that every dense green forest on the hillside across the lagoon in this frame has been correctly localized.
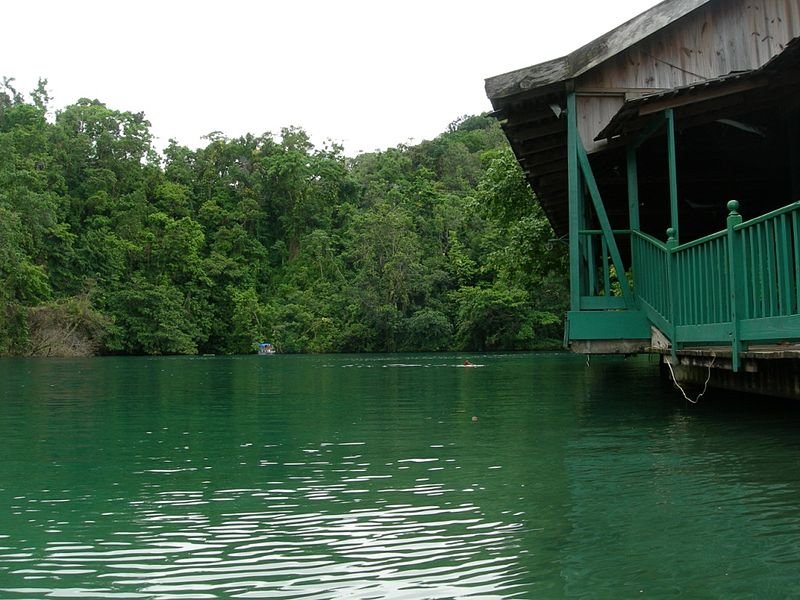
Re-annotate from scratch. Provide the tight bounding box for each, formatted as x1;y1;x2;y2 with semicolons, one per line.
0;78;567;356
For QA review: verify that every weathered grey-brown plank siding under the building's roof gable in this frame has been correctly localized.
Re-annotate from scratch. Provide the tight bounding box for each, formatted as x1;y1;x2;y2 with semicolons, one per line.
576;0;800;151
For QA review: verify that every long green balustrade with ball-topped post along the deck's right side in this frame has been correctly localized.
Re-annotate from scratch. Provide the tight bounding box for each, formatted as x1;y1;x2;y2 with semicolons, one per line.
631;201;800;370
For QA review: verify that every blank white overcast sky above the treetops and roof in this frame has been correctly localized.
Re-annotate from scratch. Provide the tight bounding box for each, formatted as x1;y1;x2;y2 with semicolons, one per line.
0;0;658;155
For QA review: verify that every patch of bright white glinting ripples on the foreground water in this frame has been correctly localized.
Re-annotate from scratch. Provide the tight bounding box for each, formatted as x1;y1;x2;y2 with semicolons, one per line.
0;472;521;599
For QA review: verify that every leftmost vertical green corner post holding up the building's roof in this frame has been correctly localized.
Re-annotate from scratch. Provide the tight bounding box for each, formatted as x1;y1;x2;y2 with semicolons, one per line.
566;92;581;311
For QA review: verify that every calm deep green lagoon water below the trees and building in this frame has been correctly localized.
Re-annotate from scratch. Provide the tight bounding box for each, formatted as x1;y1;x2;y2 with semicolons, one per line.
0;354;800;599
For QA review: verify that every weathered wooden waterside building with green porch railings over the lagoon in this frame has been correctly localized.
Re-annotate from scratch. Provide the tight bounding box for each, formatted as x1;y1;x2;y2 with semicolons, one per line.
486;0;800;398
